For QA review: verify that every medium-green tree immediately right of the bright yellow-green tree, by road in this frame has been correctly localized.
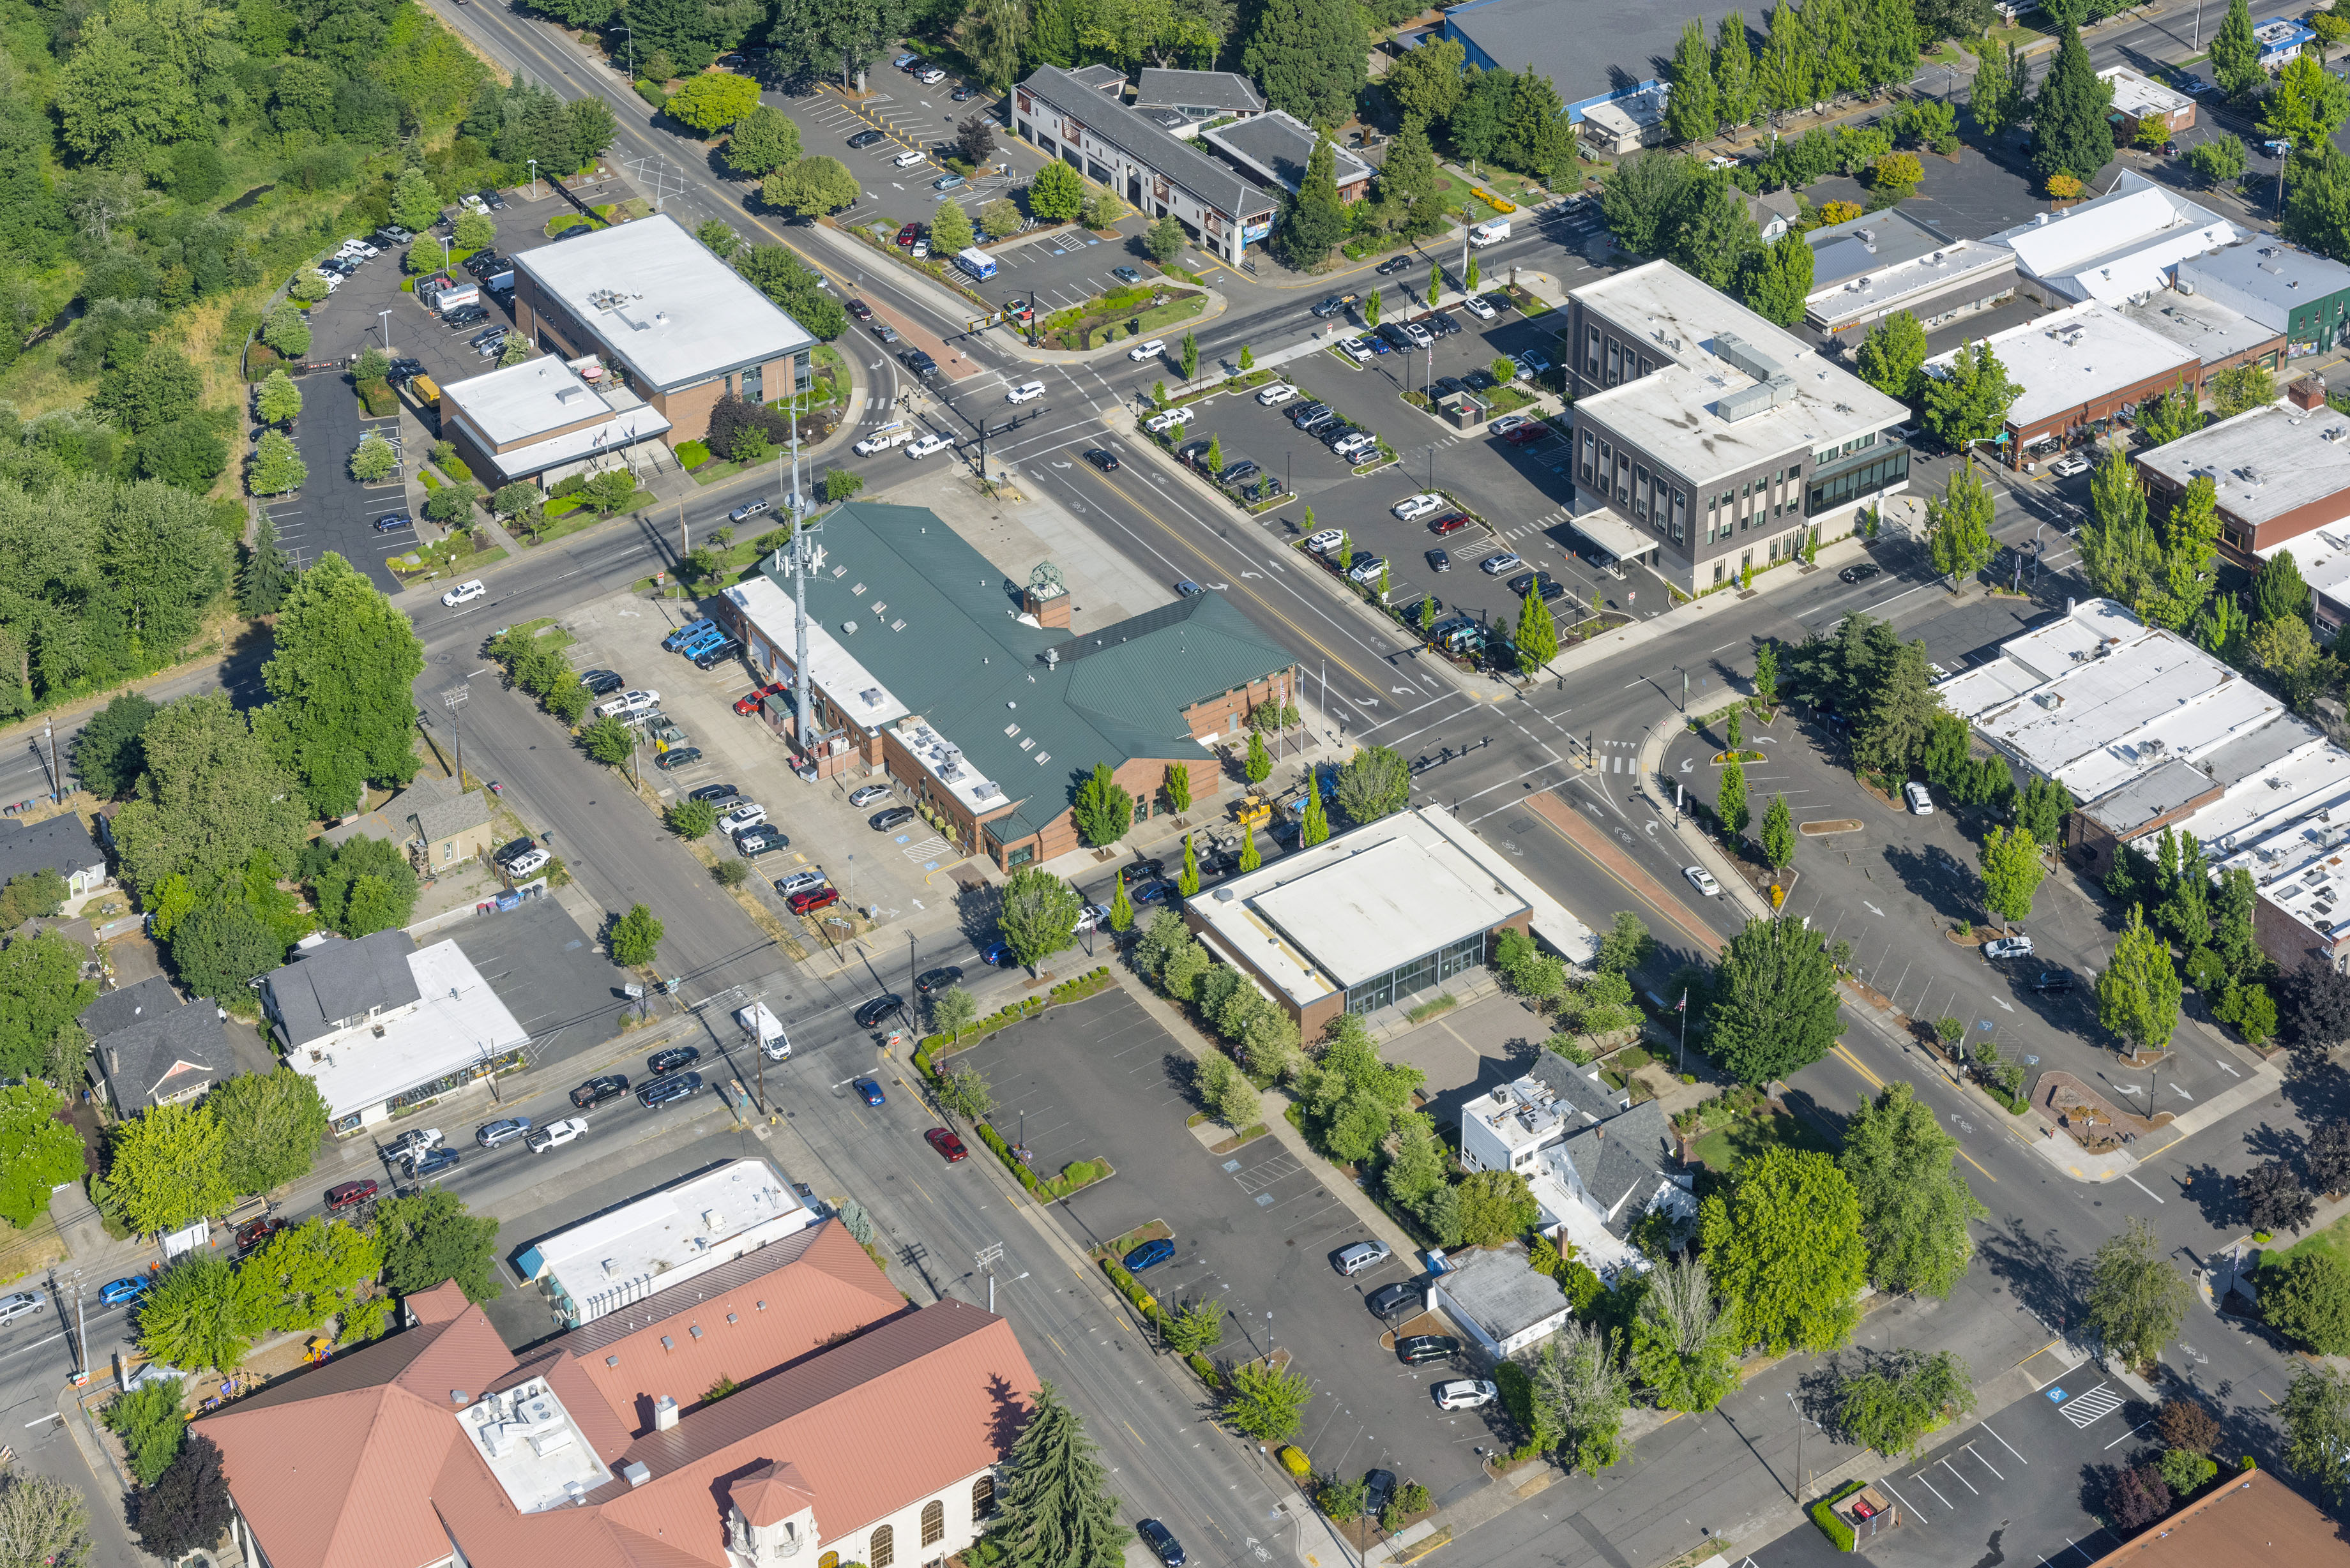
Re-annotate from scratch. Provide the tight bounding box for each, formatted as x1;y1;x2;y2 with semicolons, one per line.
1838;1083;1990;1300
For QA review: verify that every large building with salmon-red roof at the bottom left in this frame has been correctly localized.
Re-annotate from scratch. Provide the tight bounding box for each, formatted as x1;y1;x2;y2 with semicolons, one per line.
202;1220;1036;1568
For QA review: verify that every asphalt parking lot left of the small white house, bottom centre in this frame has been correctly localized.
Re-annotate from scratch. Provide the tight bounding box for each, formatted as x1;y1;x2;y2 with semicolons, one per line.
954;992;1494;1505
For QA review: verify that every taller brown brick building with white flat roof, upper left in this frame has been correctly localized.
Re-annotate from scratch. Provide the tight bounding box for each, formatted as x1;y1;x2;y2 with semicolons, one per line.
515;216;815;442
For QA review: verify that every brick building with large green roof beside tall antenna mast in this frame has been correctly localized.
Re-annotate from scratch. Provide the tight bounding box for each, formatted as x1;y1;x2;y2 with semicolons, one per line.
724;503;1297;870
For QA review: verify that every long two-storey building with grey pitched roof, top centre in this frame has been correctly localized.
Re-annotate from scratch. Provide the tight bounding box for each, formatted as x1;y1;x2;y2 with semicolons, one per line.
1013;66;1281;261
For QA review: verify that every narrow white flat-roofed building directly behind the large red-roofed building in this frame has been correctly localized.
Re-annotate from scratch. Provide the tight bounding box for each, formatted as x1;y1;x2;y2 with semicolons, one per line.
515;1161;815;1328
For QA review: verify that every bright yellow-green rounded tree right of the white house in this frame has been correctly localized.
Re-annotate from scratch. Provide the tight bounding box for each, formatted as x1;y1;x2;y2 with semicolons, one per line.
1699;1147;1869;1354
